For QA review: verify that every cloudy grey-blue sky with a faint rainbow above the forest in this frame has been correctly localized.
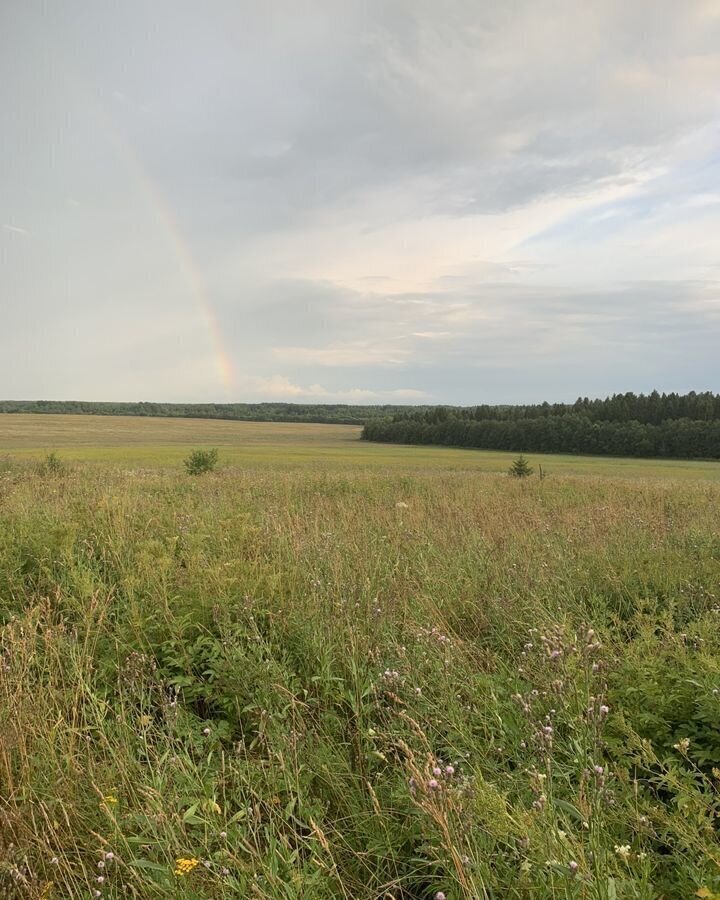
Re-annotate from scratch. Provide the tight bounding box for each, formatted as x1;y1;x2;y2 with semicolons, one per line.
0;0;720;404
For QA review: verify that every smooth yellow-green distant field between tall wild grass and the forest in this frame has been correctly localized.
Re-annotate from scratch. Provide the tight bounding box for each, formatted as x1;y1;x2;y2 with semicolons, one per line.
0;414;720;481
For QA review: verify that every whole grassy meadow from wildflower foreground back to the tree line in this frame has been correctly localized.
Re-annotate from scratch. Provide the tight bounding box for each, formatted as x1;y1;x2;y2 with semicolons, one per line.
0;415;720;900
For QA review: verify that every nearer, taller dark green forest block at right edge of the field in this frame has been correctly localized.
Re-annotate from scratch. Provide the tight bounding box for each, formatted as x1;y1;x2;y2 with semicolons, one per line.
362;391;720;459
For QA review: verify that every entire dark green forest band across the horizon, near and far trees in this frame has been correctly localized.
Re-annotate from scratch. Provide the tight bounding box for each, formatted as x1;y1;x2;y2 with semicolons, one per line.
5;391;720;459
